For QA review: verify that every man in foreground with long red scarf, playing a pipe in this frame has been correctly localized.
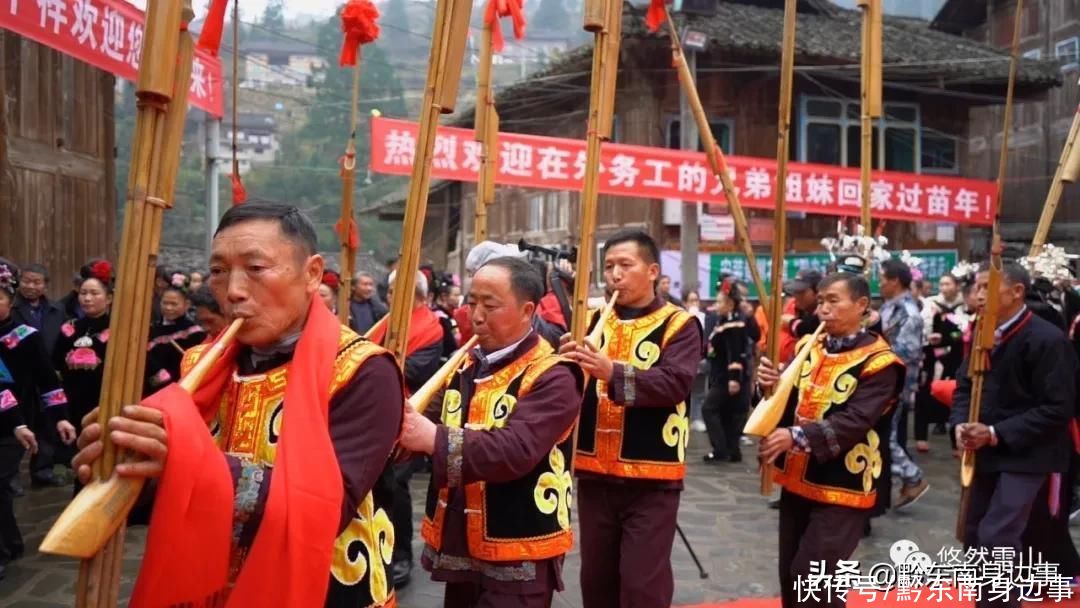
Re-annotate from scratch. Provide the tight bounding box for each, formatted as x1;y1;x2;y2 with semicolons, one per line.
75;202;404;608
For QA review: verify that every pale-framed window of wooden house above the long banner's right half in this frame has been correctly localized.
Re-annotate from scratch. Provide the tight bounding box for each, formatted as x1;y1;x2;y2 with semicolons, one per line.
797;96;921;172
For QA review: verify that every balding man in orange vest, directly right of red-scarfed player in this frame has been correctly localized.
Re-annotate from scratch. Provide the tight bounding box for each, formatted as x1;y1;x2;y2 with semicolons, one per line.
402;257;582;608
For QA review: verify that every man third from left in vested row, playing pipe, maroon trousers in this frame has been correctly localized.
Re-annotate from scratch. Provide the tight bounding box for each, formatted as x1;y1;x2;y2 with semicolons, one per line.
562;231;703;608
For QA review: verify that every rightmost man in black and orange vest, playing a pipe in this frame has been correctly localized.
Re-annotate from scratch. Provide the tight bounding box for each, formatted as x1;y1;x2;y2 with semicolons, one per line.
758;272;904;608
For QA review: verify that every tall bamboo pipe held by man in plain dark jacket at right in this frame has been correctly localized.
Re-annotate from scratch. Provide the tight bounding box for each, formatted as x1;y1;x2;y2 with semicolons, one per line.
956;0;1024;542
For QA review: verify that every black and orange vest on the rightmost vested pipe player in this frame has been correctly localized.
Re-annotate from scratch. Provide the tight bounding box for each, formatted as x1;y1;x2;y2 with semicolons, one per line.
774;336;904;509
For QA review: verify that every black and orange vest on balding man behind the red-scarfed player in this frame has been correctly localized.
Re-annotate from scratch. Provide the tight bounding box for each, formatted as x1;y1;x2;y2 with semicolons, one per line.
421;340;573;562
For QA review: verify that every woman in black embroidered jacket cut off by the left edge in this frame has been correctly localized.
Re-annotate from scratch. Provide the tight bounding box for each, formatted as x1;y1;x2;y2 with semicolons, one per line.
0;258;75;578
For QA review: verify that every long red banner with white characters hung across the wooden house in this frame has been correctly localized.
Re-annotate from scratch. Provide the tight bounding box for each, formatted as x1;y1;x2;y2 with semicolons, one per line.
372;118;997;226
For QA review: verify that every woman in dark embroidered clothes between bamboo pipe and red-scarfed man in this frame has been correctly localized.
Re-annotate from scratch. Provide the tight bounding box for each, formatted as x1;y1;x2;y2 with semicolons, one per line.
143;272;206;395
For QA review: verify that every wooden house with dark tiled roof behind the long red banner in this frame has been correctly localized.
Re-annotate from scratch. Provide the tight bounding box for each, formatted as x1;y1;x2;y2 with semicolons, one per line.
408;0;1059;278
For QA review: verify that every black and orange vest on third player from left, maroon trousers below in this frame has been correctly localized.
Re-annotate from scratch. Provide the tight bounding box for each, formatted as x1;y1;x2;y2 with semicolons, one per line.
577;303;693;481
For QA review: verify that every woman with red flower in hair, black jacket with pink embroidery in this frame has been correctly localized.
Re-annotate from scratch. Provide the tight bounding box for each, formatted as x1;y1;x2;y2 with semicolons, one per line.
53;259;112;438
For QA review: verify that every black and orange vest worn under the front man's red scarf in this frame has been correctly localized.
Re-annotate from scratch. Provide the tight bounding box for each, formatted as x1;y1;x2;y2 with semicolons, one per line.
183;325;408;608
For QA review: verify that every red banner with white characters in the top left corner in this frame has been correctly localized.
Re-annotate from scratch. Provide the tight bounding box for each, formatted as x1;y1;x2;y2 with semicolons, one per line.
0;0;225;118
